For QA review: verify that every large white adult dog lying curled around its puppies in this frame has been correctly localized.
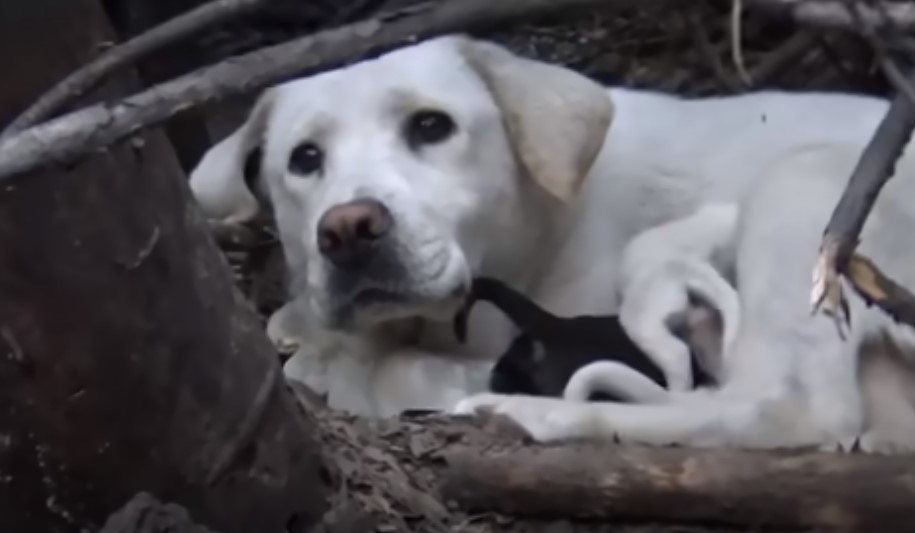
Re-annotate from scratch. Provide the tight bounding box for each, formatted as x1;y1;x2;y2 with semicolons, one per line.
191;37;915;448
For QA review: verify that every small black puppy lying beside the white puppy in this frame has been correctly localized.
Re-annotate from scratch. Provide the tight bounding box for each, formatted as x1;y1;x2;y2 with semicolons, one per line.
454;277;714;401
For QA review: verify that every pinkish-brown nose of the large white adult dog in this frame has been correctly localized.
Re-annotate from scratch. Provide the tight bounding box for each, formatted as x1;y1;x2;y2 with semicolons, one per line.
318;198;393;269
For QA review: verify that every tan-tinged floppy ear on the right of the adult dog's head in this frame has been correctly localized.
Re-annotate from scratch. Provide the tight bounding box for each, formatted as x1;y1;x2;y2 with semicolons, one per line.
458;37;613;201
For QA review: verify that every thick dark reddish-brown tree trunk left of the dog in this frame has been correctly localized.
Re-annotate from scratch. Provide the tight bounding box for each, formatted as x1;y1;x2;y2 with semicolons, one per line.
0;0;329;533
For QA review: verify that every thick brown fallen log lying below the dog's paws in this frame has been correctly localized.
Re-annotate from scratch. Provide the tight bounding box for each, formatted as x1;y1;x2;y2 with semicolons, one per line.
442;438;915;531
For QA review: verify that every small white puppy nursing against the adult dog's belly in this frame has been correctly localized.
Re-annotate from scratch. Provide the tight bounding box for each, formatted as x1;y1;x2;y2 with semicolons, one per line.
563;202;740;404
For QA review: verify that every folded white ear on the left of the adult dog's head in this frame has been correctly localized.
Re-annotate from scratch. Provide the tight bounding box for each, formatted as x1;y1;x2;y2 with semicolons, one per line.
190;89;276;223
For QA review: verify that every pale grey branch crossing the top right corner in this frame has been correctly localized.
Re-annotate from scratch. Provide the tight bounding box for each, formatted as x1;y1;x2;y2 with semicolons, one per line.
747;0;915;32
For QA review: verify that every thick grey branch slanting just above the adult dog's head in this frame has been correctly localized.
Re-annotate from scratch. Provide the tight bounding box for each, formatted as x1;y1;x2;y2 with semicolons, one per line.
0;0;638;181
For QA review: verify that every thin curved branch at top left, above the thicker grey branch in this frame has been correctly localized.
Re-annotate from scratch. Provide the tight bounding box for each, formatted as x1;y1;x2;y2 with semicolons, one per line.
0;0;270;141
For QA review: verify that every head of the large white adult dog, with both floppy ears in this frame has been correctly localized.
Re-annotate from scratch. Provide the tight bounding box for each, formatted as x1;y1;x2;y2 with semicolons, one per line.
191;36;612;327
